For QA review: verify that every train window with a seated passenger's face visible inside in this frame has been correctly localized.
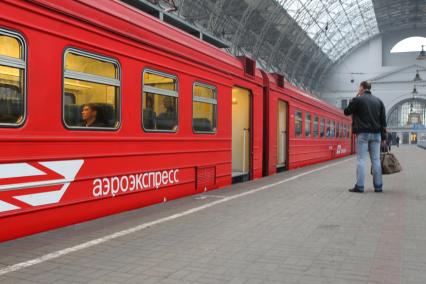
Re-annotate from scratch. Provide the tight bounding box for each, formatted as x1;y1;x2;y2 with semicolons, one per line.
63;48;120;129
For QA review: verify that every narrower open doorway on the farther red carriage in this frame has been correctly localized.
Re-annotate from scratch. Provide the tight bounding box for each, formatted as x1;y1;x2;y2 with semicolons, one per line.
277;100;288;172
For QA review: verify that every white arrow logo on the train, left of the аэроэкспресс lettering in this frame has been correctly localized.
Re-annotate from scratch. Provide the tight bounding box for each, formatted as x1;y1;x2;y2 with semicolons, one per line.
0;160;84;212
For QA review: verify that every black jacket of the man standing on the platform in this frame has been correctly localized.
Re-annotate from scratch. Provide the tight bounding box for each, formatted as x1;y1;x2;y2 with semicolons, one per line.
344;91;386;139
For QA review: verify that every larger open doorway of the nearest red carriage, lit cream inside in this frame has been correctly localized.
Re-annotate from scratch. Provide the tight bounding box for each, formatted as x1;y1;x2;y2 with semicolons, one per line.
232;87;251;182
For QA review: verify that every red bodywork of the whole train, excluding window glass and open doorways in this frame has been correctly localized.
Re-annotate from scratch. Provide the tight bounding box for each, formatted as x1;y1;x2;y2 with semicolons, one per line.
0;0;351;241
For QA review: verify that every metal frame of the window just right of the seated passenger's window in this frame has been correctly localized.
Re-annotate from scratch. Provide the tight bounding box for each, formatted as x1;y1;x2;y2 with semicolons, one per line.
141;68;179;133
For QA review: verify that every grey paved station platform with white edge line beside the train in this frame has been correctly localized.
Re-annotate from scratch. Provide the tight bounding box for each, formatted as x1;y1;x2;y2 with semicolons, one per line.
0;146;426;284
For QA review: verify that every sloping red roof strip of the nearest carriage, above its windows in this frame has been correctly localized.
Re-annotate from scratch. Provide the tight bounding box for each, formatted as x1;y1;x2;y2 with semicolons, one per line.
33;0;261;80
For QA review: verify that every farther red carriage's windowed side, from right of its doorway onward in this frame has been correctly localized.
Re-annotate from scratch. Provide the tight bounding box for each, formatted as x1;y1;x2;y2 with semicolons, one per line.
286;84;351;169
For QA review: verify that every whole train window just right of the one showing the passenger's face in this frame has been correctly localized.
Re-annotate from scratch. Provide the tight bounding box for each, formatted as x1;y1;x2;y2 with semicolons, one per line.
142;70;179;132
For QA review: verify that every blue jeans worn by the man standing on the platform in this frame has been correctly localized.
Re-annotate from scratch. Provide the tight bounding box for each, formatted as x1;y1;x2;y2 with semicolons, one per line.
355;133;383;191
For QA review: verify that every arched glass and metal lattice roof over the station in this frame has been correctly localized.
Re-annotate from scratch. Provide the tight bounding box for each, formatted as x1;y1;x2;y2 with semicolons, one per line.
128;0;426;93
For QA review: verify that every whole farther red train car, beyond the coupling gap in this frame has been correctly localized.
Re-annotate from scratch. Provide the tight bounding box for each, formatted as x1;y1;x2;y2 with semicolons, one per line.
262;72;351;175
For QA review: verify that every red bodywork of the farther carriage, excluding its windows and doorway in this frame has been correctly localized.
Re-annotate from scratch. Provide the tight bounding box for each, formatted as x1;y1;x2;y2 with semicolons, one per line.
263;73;352;175
